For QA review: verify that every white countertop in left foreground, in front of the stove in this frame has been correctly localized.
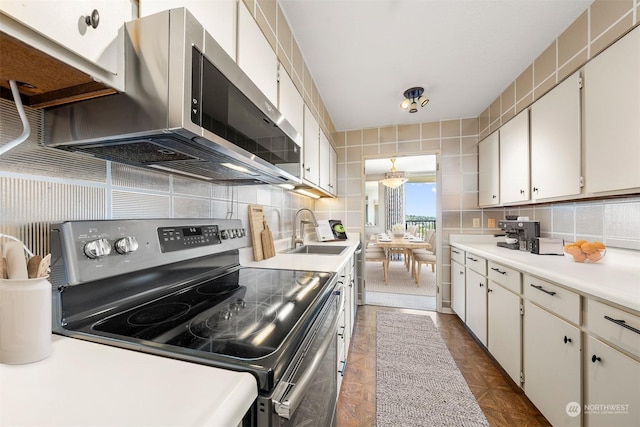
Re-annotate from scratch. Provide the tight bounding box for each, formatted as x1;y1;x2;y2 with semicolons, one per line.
0;335;258;427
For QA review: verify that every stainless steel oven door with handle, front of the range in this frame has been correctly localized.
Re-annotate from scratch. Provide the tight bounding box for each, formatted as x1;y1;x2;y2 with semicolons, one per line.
258;287;345;427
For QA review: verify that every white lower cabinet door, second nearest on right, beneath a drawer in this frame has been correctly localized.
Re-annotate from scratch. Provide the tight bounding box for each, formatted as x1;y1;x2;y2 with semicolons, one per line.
523;301;582;427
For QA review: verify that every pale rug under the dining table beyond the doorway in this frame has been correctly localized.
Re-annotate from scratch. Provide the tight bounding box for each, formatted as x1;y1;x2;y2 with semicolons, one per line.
365;261;436;297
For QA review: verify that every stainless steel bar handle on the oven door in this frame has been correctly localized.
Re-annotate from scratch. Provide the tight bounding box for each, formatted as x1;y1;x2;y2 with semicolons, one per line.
274;286;346;419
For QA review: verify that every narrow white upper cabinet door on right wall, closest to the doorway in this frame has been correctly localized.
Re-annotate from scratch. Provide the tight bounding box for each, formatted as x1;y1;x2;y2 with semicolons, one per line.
478;132;500;207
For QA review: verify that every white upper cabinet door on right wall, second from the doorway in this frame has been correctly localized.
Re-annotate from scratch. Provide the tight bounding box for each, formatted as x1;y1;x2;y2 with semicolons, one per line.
500;110;530;204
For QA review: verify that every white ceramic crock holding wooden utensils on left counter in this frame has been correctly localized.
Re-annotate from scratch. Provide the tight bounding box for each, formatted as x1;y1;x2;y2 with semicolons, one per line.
0;278;51;365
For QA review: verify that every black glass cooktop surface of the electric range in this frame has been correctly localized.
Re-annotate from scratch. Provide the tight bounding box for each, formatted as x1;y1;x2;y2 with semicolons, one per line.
91;268;331;359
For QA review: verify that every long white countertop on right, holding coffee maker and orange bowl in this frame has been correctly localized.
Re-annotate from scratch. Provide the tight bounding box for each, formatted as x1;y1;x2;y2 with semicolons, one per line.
450;234;640;313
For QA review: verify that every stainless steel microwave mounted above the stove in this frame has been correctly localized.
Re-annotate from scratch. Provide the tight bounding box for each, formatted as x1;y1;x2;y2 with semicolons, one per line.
44;8;302;185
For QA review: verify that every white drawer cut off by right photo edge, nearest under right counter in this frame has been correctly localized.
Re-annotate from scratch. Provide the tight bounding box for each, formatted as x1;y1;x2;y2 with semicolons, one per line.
587;300;640;357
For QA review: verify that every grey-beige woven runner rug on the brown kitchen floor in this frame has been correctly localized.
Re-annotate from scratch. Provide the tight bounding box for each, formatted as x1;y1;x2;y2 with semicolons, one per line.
376;311;489;427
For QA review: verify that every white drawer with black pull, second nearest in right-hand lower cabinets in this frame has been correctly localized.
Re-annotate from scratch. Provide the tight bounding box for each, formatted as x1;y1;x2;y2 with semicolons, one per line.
524;274;580;325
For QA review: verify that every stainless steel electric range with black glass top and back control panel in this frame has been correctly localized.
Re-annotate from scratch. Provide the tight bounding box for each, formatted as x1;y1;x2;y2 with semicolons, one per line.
51;219;344;427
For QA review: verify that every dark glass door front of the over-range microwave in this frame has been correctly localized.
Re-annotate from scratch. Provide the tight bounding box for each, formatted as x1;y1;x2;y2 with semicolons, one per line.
191;47;301;178
